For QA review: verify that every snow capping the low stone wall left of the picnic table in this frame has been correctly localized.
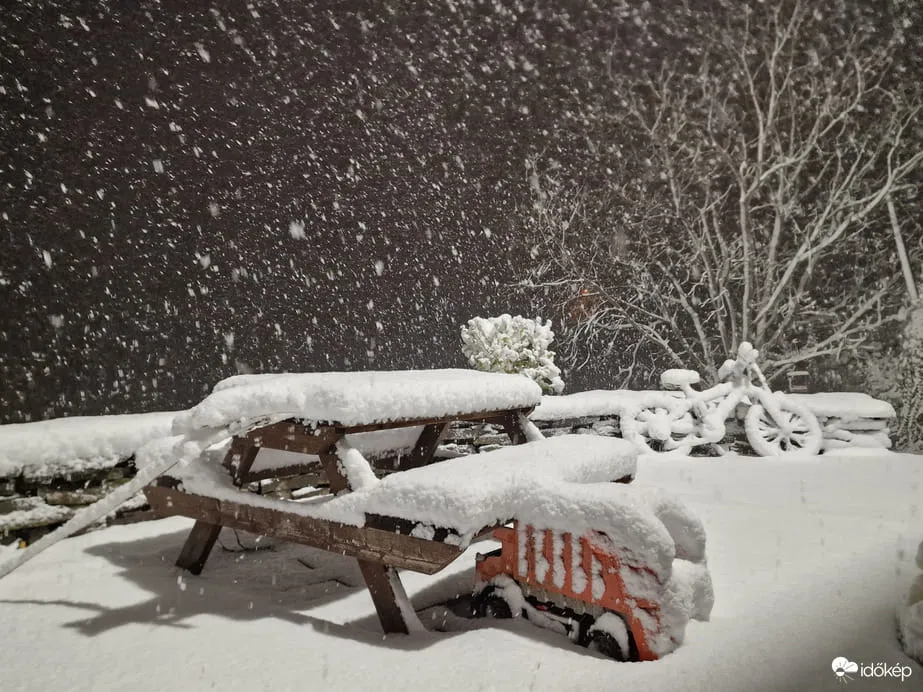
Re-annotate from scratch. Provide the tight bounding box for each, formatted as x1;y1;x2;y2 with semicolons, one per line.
0;412;176;478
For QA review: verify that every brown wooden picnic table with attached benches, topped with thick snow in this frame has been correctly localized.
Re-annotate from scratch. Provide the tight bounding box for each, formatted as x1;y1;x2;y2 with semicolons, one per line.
145;370;635;633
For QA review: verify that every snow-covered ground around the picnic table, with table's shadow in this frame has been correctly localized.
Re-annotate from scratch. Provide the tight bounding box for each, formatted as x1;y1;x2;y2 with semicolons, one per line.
0;451;923;692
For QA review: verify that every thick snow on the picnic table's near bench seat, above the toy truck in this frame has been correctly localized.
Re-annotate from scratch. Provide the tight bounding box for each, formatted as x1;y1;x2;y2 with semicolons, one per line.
153;435;638;543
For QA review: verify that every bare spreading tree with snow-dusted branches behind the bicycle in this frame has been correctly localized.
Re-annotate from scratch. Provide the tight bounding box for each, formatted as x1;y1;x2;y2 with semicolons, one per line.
529;2;923;386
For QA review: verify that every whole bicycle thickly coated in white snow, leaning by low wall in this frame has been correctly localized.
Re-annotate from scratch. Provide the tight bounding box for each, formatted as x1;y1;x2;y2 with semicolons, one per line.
620;341;823;456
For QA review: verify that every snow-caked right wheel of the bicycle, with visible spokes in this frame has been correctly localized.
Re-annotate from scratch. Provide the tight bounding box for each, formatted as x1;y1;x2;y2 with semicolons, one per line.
746;399;824;457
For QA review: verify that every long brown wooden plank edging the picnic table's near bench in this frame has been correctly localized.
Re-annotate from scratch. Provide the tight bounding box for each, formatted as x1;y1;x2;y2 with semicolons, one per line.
144;485;463;574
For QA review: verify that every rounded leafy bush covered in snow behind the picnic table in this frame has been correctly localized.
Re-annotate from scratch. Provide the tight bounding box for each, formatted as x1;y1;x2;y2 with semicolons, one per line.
461;315;564;394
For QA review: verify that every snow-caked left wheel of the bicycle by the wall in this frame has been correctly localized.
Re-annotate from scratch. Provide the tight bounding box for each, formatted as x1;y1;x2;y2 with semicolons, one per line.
619;395;696;455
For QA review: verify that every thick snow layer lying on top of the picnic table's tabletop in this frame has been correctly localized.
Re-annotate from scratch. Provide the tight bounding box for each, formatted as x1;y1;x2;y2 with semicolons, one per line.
173;369;541;434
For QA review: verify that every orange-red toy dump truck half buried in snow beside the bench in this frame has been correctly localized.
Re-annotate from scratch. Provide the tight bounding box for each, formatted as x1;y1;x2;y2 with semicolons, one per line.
473;522;665;661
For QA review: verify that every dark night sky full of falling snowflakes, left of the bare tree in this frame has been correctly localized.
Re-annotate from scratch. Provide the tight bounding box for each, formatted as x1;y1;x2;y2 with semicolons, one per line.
0;0;636;422
